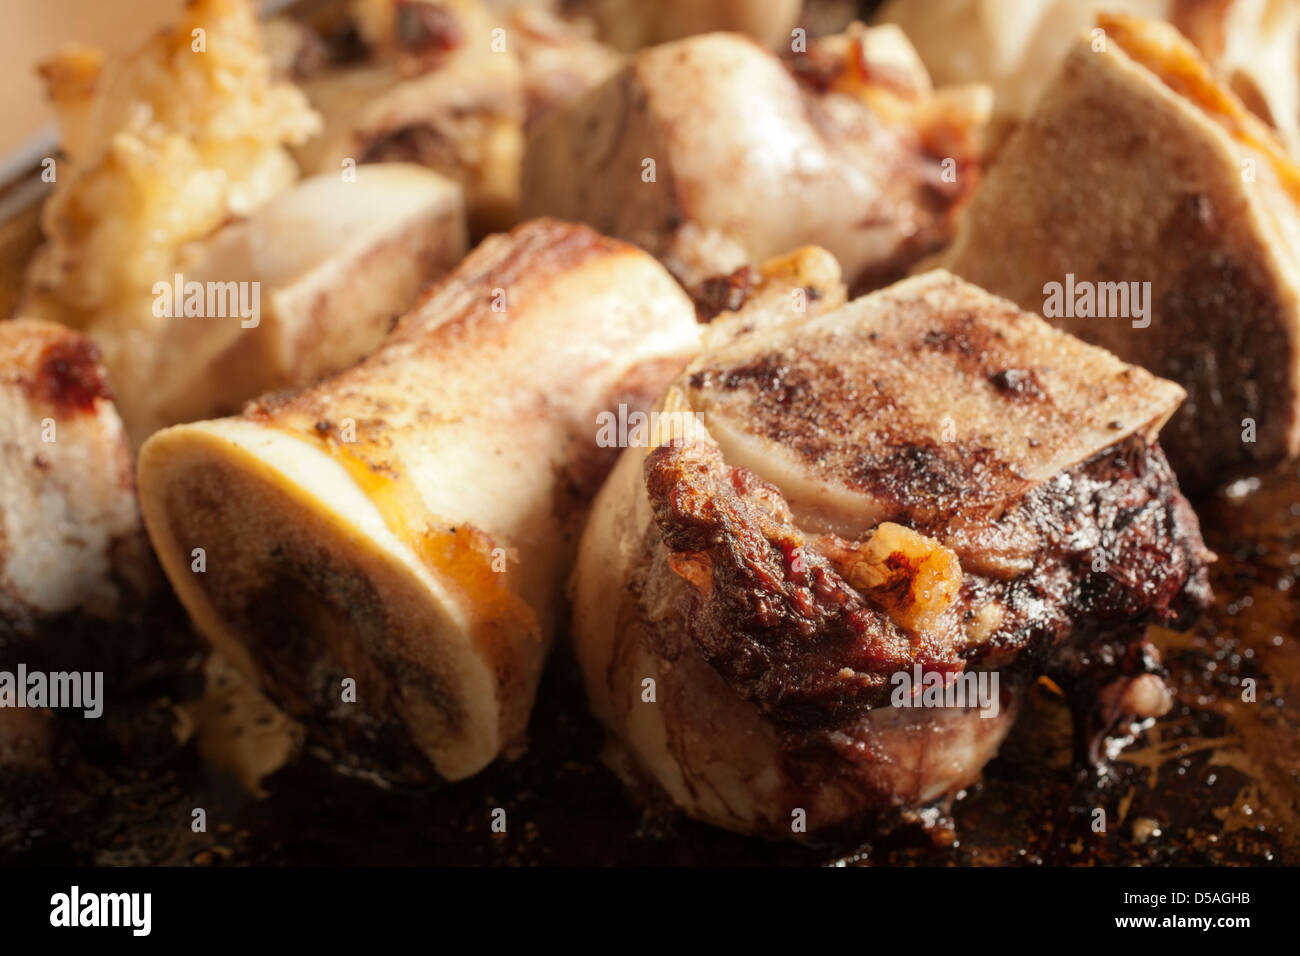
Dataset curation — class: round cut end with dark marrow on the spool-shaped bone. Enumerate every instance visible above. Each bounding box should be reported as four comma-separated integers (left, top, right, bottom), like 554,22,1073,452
139,420,512,780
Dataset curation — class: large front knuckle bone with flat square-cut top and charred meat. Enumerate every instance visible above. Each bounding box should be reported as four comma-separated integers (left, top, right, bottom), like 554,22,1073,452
572,272,1212,836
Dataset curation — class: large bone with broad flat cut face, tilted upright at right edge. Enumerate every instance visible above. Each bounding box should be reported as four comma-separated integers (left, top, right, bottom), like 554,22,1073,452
937,16,1300,493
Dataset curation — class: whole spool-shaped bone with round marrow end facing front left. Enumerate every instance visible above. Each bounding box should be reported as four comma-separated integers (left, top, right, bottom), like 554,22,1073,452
139,221,699,779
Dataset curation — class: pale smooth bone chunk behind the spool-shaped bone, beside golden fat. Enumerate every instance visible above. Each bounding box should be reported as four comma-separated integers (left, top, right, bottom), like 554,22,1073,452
144,163,467,433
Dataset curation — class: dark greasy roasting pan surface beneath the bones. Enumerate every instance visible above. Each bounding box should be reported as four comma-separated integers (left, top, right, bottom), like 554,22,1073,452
0,0,1300,866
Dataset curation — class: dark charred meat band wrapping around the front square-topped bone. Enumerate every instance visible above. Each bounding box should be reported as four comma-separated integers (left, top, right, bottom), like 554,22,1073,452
645,437,1210,731
